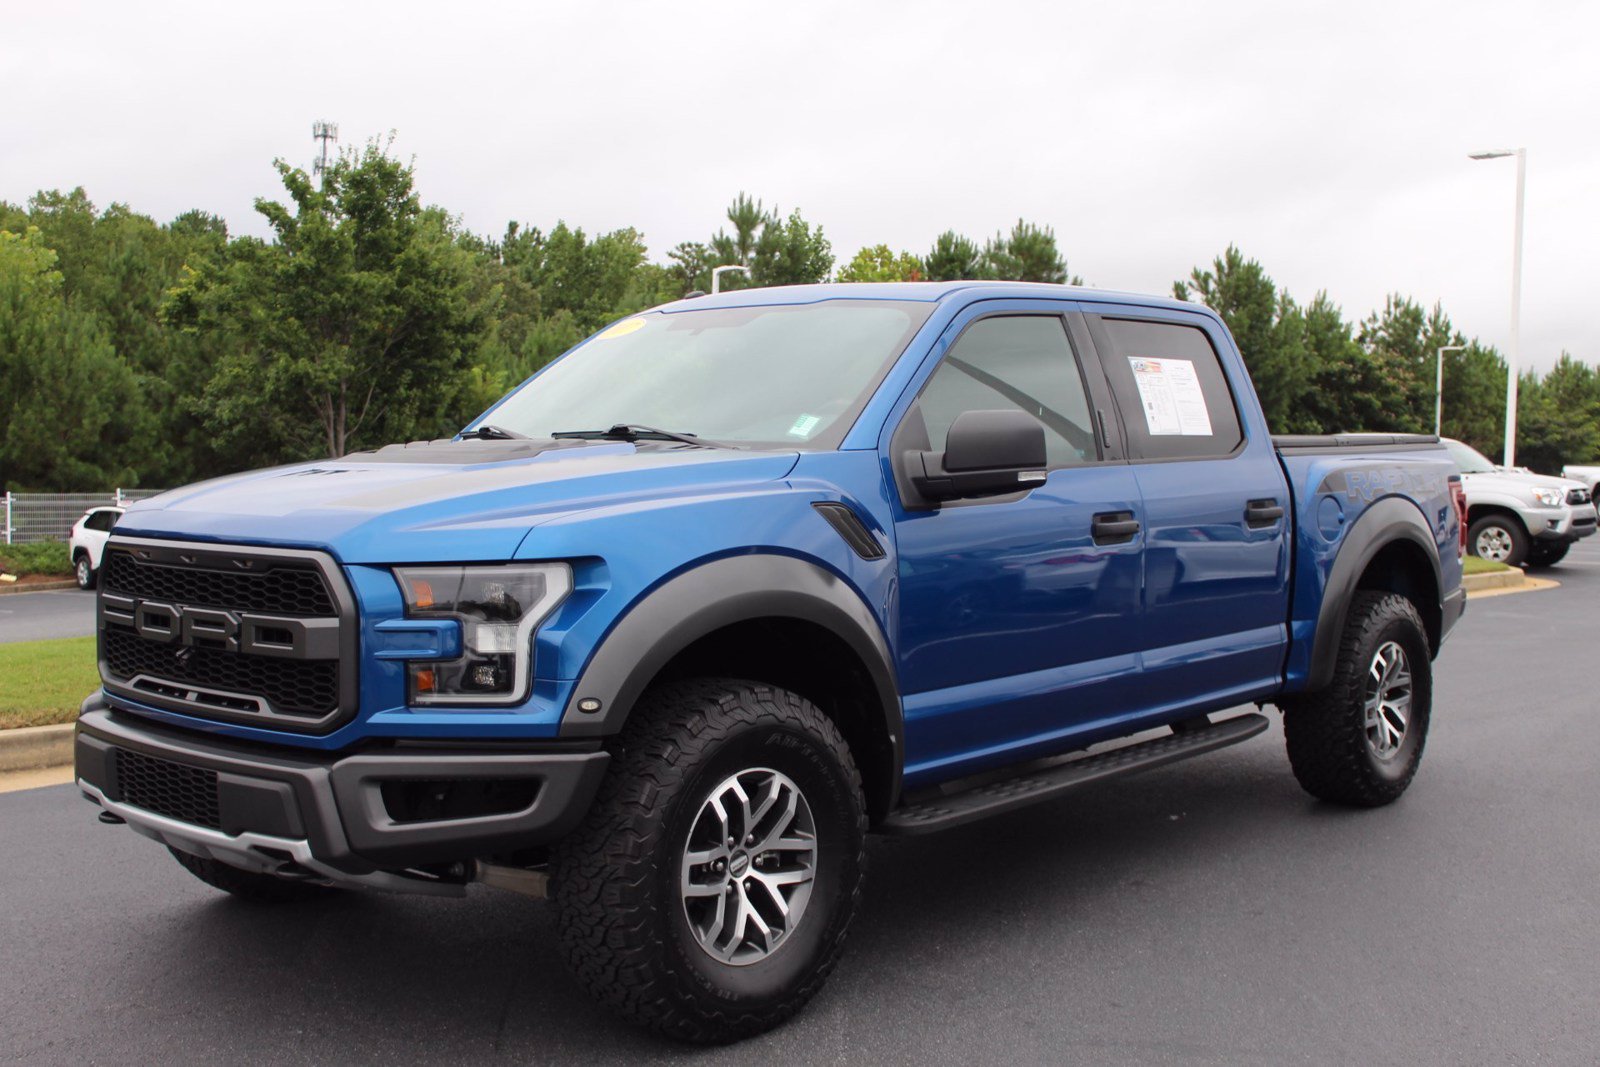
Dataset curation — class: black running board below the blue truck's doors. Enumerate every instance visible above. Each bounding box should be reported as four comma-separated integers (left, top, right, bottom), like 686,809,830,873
877,713,1267,837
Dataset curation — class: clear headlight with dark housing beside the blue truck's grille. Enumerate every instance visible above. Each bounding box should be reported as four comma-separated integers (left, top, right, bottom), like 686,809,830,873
395,563,573,704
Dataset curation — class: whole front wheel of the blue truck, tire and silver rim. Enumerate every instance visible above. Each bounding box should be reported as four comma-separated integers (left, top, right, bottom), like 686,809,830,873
552,680,867,1043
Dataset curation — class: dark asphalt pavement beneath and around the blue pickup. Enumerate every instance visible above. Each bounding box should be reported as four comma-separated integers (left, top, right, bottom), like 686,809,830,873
0,542,1600,1064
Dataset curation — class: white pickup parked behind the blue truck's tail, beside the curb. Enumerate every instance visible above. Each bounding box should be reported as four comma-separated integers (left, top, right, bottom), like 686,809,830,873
1445,437,1595,566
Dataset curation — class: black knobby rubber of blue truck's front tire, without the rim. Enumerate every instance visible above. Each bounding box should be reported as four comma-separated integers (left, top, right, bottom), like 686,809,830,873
550,678,867,1045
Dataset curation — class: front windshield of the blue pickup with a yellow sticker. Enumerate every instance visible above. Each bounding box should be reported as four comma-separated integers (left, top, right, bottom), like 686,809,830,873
485,299,933,450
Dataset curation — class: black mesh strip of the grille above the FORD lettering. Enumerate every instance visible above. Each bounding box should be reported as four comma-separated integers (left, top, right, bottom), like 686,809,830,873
101,550,338,619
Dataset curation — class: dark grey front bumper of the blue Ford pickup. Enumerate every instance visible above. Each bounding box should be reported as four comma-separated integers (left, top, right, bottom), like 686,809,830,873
74,694,610,894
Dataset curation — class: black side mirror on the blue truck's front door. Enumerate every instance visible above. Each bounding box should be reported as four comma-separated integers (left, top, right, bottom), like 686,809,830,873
906,408,1048,501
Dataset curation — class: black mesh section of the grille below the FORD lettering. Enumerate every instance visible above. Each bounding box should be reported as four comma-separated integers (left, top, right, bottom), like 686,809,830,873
101,624,339,718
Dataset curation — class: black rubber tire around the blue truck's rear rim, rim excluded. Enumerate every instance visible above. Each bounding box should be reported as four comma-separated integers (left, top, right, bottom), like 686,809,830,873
1282,592,1434,808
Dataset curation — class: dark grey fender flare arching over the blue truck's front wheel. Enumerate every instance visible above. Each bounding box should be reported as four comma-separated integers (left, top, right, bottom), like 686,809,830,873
560,553,906,803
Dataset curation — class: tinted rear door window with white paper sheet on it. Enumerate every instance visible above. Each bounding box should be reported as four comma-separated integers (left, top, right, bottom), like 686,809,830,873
1096,318,1243,459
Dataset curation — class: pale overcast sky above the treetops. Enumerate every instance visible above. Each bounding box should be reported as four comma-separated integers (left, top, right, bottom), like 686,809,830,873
0,0,1600,366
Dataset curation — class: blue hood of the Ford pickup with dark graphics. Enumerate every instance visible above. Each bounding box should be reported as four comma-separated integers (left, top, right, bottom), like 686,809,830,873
117,440,798,563
